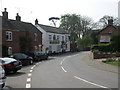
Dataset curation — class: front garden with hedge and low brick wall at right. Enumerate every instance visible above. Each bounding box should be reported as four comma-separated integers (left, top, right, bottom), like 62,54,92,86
91,35,120,66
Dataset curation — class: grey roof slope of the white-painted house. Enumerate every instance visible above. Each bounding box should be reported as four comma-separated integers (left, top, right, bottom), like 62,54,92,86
38,24,68,34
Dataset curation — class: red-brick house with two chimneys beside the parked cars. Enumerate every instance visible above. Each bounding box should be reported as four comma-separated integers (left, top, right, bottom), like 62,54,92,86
1,8,42,56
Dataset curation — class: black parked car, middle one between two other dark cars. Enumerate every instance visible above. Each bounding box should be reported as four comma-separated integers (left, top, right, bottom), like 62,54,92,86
9,53,33,65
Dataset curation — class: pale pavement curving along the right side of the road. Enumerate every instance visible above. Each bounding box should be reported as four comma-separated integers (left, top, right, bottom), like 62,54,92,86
84,52,120,74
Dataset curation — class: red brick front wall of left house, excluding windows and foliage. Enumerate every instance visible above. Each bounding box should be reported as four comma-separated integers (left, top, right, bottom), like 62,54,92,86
2,30,42,56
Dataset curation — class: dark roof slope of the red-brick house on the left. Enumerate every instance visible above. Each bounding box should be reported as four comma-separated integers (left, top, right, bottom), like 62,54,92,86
2,18,40,32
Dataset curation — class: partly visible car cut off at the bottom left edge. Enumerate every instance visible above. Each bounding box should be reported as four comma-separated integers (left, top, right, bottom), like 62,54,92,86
0,62,6,90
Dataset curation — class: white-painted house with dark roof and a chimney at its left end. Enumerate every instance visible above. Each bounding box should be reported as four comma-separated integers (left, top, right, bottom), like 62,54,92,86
35,19,70,53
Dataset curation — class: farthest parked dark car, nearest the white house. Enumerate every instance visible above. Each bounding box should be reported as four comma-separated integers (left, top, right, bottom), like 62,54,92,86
29,51,48,61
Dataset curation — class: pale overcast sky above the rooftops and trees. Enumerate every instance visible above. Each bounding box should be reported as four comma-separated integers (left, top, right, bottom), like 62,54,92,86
0,0,120,25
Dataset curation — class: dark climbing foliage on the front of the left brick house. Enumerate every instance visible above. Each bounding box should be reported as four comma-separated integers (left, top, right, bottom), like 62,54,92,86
20,36,32,53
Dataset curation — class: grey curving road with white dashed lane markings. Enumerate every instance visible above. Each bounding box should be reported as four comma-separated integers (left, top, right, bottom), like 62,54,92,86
3,52,118,90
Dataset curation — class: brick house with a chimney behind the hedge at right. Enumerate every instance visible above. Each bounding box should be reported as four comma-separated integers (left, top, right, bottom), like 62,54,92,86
98,19,120,43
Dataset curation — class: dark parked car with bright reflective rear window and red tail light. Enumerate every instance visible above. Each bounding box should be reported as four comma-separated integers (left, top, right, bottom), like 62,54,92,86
0,58,22,74
